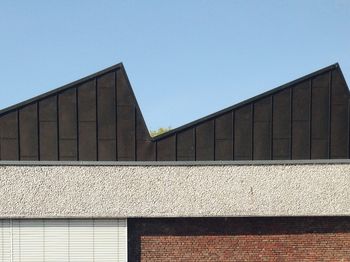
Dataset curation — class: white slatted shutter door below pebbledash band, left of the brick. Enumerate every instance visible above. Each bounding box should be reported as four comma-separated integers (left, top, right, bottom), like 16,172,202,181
0,219,127,262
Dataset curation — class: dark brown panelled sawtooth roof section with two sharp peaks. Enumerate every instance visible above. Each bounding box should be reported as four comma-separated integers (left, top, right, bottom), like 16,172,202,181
0,64,349,161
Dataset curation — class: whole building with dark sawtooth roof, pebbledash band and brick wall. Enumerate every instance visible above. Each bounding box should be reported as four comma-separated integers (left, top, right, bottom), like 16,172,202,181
0,64,350,261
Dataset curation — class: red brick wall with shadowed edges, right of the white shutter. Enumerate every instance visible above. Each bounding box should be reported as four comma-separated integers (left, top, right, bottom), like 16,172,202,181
128,217,350,262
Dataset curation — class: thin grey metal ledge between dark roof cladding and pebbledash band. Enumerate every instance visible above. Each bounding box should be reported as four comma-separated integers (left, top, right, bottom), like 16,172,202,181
0,159,350,166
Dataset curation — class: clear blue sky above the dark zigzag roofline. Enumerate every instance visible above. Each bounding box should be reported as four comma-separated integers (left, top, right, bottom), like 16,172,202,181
0,0,350,129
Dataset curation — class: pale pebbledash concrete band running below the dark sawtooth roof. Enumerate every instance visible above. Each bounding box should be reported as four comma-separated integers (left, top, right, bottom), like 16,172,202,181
0,163,350,218
